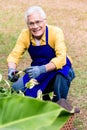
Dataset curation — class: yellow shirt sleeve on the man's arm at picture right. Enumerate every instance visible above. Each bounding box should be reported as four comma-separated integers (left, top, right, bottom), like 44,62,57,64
51,28,66,69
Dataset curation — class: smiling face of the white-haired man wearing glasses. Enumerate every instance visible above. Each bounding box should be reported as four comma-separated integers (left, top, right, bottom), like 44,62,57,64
27,12,46,39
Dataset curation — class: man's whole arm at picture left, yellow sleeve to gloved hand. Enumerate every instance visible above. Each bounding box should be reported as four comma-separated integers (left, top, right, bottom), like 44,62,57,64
7,29,29,82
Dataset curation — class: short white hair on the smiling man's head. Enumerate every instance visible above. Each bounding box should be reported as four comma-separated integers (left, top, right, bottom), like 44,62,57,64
25,6,46,22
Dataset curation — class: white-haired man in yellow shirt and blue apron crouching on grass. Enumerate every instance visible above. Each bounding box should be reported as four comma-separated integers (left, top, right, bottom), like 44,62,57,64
7,6,75,102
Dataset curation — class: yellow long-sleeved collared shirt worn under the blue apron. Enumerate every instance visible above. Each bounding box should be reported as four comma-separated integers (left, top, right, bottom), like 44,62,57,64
7,25,71,69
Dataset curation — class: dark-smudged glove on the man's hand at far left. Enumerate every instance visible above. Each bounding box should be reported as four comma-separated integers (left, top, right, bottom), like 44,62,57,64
8,68,19,82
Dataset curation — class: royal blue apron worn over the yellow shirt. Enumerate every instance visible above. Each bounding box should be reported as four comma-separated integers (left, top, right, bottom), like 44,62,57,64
23,27,71,97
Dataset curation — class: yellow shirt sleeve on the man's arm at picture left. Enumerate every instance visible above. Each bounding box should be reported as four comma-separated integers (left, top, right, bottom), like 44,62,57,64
7,30,29,64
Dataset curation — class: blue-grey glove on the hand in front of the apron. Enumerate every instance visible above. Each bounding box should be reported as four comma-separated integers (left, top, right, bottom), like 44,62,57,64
24,65,46,78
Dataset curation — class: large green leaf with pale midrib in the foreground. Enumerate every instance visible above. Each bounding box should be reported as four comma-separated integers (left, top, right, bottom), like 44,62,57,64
0,95,71,130
